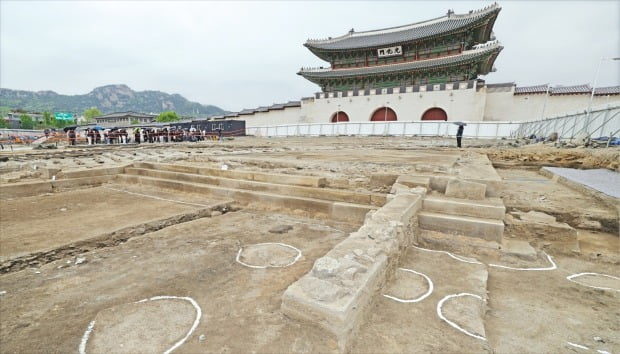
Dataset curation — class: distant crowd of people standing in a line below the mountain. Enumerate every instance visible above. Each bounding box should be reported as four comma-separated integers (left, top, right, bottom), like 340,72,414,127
67,127,222,145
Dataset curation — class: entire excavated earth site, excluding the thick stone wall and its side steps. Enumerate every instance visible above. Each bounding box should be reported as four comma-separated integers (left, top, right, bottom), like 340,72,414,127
0,137,620,353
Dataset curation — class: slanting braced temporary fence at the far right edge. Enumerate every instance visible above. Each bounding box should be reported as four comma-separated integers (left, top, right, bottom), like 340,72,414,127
513,105,620,139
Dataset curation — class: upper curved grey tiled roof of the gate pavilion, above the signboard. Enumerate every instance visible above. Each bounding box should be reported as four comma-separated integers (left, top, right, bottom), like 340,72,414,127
304,3,501,50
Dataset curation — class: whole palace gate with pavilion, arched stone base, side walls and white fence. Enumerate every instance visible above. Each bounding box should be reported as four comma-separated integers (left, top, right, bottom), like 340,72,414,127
224,4,620,138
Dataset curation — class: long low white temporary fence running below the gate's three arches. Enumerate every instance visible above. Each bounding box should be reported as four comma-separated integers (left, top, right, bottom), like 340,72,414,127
246,121,521,139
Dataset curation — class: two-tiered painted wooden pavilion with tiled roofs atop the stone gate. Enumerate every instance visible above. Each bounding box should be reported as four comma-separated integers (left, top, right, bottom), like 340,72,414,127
298,4,503,92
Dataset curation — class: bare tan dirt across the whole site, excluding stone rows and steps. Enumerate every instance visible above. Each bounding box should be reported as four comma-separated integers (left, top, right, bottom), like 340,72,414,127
0,137,620,353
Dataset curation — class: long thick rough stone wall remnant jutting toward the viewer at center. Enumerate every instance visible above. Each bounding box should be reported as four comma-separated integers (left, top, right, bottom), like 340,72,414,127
282,193,422,351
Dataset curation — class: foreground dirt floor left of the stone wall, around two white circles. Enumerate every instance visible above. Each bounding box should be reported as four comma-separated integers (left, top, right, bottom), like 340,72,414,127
0,210,359,353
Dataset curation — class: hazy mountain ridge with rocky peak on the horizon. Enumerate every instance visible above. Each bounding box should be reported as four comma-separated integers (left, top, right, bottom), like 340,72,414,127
0,84,228,117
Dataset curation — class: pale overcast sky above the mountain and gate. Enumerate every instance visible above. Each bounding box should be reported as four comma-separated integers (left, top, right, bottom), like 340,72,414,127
0,0,620,111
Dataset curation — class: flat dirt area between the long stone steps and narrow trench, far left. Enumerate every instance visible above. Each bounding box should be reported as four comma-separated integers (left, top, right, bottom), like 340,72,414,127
0,185,215,262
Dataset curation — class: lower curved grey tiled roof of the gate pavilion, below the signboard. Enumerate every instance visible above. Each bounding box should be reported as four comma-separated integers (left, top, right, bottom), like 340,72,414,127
297,41,503,79
